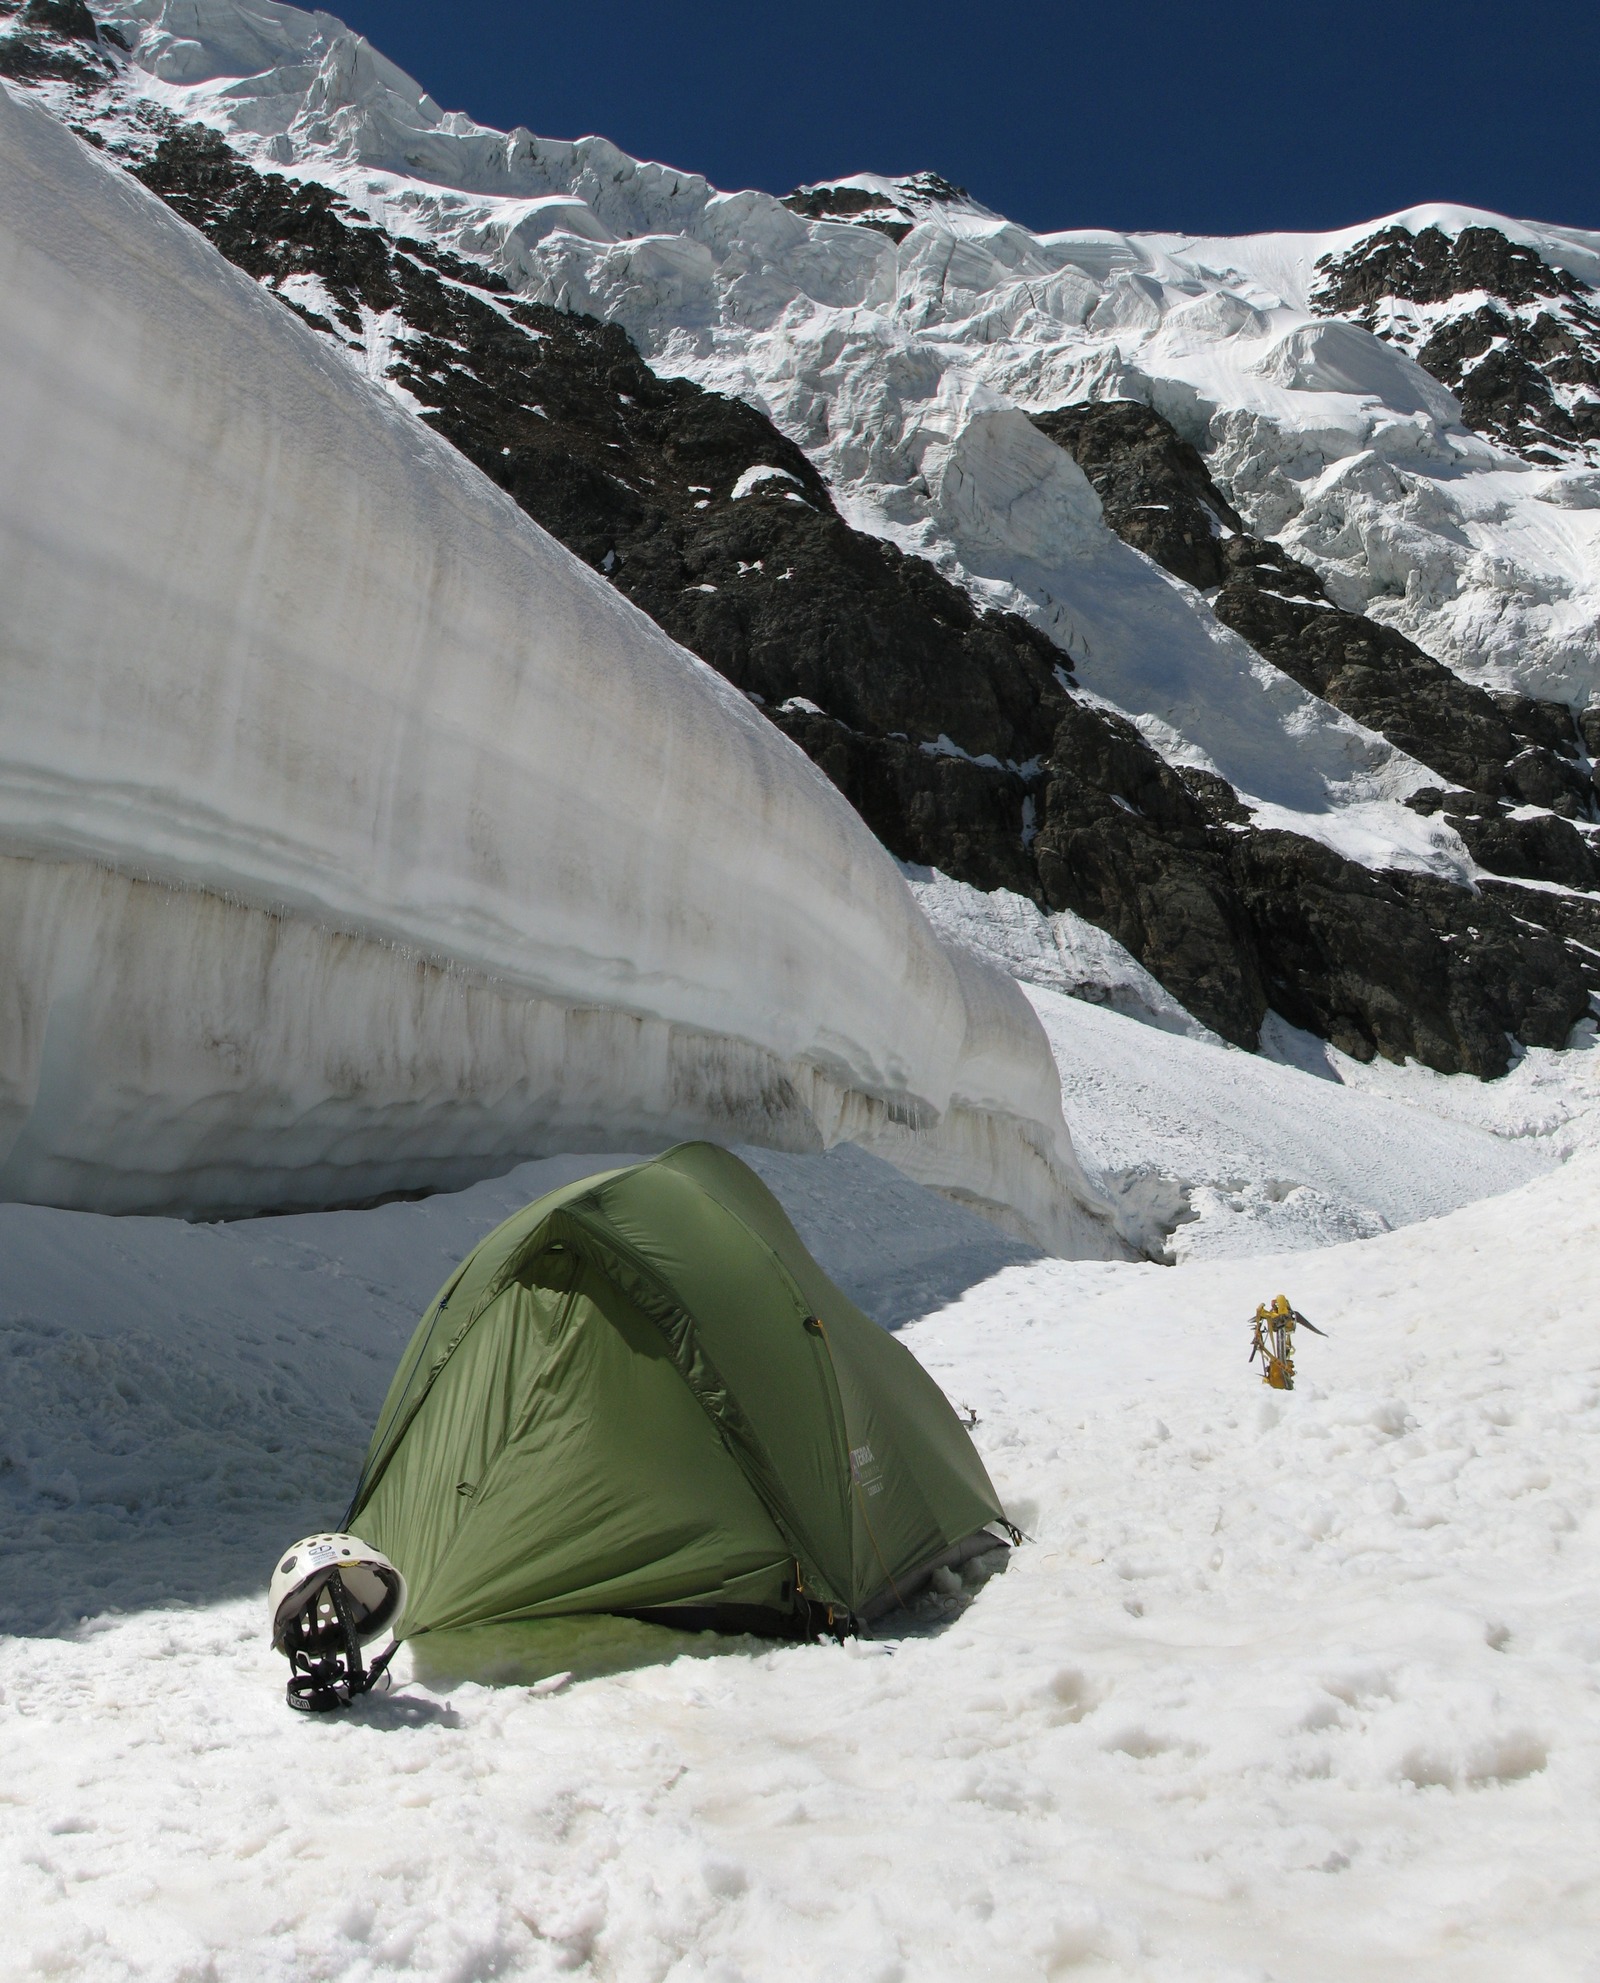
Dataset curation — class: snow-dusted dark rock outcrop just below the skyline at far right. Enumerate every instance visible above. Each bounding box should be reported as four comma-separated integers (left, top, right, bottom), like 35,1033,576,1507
1313,226,1600,462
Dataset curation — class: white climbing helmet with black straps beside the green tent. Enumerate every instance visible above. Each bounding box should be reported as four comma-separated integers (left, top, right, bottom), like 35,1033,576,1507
268,1535,406,1713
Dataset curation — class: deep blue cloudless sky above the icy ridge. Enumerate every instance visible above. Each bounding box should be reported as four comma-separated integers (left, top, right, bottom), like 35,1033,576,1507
329,0,1600,234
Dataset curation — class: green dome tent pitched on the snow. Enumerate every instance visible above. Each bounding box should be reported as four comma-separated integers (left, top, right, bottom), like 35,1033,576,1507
345,1142,1005,1638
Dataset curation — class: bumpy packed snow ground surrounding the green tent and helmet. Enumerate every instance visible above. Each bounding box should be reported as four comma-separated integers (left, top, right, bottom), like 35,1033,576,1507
0,1142,1600,1983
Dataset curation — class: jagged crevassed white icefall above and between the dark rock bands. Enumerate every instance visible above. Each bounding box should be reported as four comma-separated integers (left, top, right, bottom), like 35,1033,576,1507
34,0,1600,873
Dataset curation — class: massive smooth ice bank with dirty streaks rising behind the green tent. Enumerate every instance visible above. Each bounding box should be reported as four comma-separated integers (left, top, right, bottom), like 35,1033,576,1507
0,91,1116,1251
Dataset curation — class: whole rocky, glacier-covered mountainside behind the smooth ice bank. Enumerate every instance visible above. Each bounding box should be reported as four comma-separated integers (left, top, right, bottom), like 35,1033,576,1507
0,0,1600,1197
